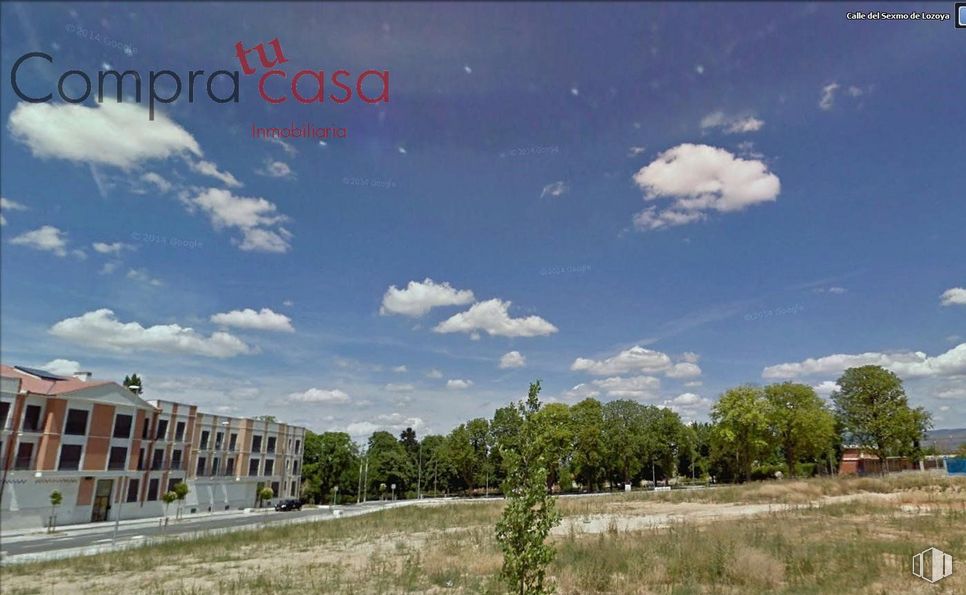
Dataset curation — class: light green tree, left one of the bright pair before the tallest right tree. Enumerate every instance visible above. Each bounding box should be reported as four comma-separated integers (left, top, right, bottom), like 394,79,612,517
711,386,773,481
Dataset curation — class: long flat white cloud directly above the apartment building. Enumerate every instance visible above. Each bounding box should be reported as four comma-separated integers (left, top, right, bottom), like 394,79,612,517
50,308,252,358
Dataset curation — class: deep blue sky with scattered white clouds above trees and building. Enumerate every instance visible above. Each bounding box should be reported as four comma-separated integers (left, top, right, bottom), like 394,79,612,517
0,3,966,437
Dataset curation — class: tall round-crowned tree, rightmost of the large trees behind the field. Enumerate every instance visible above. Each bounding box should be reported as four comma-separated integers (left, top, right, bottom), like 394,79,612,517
832,366,932,463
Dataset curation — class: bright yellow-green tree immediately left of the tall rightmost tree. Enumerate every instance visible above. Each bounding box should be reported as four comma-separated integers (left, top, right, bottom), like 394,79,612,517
765,382,836,476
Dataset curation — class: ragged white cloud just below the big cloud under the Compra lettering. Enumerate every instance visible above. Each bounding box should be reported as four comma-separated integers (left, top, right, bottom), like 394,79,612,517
188,188,292,252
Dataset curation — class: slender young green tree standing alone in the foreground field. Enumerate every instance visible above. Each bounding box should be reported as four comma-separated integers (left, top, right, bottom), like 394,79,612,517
496,380,560,595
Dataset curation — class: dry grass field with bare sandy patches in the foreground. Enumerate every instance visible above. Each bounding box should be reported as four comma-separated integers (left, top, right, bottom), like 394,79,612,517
0,474,966,595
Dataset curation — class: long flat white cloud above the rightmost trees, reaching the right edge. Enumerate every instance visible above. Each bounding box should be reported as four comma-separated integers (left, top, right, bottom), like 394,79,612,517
761,343,966,379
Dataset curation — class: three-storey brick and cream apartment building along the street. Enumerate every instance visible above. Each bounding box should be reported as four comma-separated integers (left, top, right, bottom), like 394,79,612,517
0,365,305,529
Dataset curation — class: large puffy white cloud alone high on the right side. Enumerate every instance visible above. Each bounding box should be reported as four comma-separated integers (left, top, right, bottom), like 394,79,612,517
634,144,781,230
